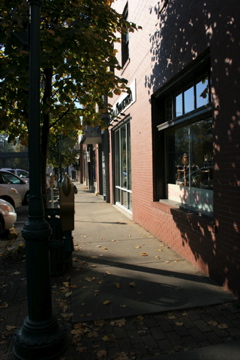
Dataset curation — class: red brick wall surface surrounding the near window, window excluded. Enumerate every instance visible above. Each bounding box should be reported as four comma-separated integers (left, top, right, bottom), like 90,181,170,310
110,0,240,295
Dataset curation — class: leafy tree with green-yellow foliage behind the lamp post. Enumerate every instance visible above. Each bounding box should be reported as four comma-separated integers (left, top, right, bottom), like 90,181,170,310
0,0,137,197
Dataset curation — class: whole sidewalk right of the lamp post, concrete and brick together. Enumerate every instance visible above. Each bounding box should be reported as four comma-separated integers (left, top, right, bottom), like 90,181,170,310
0,185,240,360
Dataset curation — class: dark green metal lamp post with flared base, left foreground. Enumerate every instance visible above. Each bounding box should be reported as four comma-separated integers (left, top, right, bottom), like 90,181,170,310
13,0,68,360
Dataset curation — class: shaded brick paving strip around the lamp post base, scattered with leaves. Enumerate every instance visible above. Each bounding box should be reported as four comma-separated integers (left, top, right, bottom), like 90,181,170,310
0,250,240,360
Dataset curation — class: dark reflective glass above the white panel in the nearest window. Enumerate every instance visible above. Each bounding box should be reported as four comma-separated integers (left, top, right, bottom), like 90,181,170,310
167,120,213,189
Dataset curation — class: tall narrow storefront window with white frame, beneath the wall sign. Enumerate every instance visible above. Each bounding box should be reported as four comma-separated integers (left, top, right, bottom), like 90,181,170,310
114,122,132,210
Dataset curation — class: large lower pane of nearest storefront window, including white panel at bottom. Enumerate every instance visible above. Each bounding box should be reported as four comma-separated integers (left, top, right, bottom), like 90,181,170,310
166,119,213,213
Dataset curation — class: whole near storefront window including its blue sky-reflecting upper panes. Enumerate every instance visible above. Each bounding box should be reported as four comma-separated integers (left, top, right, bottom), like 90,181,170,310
156,64,213,215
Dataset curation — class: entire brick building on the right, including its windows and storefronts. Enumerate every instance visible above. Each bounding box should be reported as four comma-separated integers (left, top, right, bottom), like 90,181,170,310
81,0,240,296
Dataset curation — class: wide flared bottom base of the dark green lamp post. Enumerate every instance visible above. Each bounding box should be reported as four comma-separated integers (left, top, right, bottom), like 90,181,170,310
13,317,69,360
